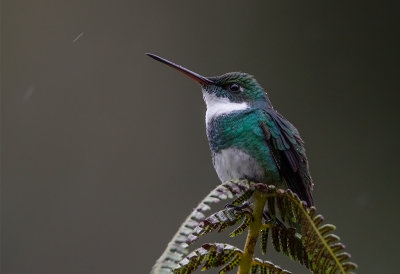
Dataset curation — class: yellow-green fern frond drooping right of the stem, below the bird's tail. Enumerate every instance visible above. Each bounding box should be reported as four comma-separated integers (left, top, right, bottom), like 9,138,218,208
262,186,357,273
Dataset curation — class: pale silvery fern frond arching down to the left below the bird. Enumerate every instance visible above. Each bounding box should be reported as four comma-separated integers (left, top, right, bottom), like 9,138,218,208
151,180,254,274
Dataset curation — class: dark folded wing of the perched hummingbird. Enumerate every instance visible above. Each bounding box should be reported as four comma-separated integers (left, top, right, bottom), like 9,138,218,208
260,109,314,206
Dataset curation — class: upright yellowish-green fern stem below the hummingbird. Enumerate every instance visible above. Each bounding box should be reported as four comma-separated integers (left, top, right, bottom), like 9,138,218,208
237,189,267,274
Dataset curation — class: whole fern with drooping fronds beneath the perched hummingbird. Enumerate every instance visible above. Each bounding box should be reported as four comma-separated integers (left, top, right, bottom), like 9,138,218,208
152,180,357,273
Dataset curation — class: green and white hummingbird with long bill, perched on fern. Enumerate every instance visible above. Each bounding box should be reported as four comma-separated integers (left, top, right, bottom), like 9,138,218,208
146,53,314,206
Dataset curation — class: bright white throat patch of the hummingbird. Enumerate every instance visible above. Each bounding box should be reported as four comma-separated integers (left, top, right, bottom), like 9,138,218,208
203,91,249,124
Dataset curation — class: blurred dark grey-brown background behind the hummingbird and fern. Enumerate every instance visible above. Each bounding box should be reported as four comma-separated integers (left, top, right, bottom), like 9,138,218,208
1,0,400,274
